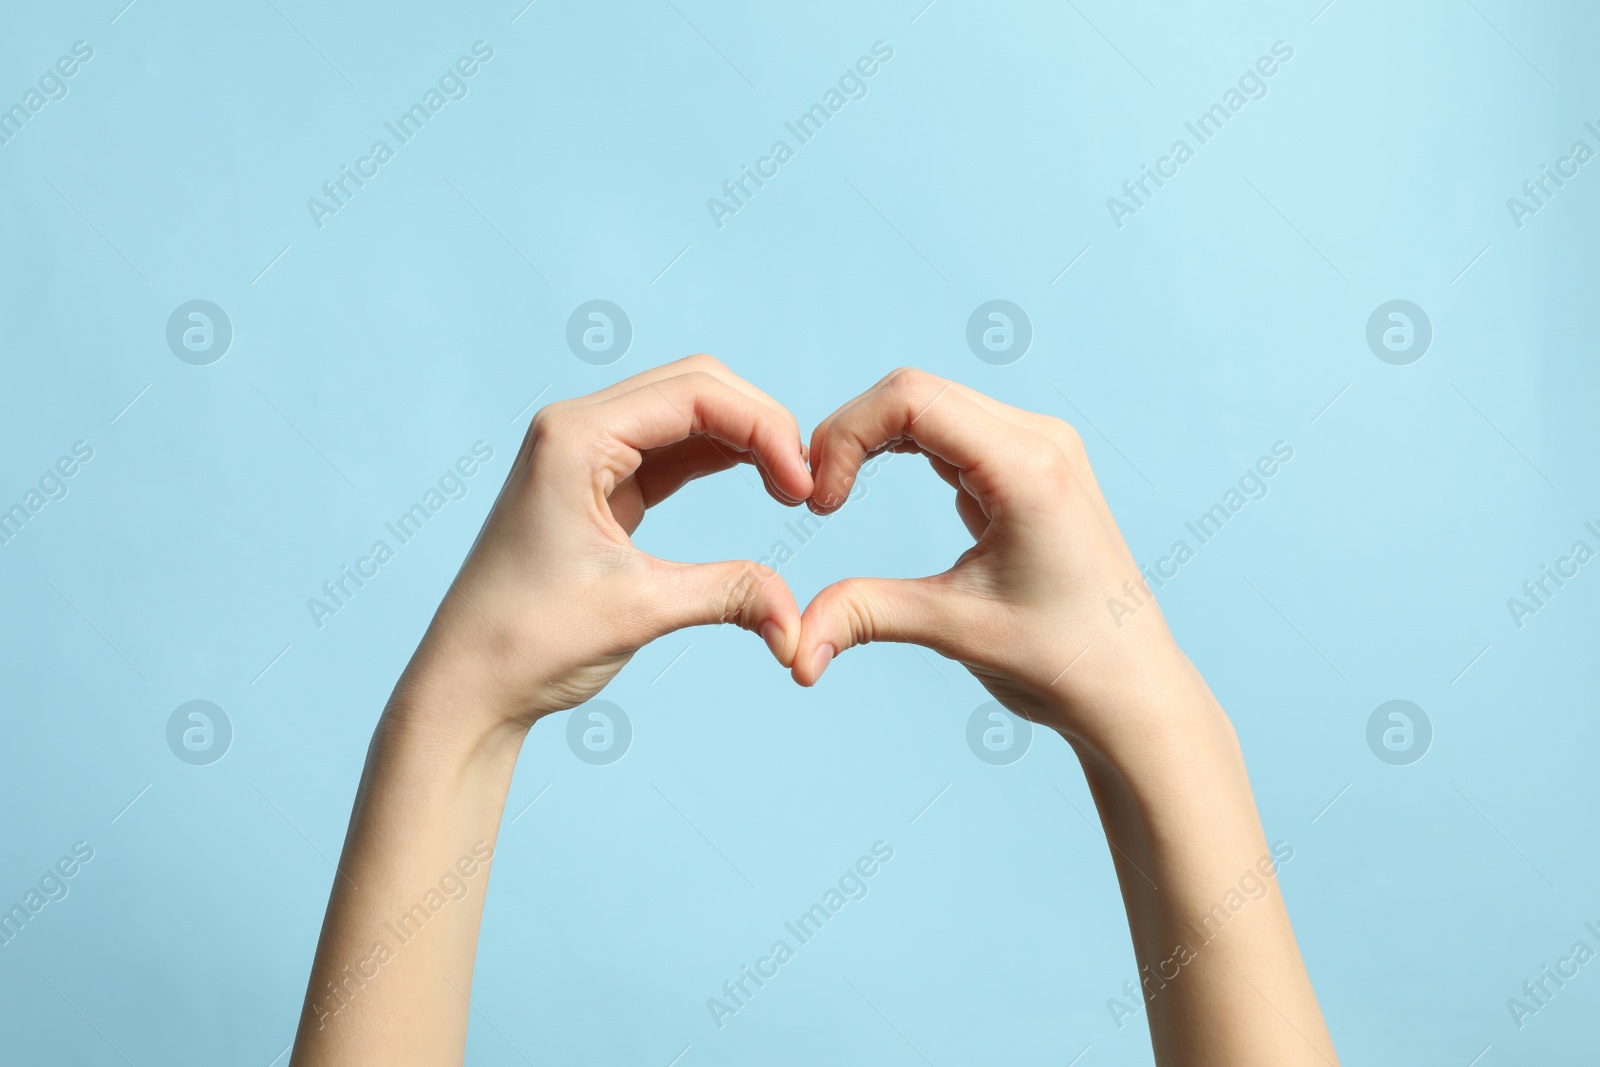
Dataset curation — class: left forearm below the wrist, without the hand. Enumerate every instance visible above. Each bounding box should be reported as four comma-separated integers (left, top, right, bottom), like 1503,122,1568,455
291,672,525,1067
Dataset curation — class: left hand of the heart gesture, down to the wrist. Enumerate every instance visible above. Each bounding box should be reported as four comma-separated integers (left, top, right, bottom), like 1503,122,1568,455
397,355,811,729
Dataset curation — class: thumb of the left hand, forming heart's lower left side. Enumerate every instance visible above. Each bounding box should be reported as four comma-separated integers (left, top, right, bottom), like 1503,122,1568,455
646,560,800,667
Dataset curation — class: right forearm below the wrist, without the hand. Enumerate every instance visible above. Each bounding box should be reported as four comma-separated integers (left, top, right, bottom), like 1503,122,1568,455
1074,653,1338,1067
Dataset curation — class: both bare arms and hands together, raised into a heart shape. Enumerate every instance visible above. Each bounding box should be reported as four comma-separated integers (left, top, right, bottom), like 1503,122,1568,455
293,355,1338,1067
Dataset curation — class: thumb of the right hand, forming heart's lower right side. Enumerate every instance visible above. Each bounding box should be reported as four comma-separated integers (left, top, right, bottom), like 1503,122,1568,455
792,577,958,686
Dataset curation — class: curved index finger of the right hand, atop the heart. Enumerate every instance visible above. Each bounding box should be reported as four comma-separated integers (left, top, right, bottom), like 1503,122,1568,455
811,370,1038,512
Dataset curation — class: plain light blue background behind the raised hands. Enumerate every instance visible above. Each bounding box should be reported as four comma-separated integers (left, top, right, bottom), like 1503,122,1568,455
0,0,1600,1067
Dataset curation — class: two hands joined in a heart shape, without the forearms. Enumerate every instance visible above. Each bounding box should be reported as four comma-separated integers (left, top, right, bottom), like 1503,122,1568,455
489,355,1139,726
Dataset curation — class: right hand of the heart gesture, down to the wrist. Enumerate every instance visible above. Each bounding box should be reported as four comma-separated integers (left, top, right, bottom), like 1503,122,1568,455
794,370,1192,751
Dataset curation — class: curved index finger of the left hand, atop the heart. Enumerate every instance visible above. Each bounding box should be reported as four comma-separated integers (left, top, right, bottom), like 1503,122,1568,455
588,371,811,502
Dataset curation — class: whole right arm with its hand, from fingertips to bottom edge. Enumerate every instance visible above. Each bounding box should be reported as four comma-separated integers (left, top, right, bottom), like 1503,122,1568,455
794,370,1338,1067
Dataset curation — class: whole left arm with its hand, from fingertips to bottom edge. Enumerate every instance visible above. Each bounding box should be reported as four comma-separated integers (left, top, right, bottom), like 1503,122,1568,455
293,357,811,1067
